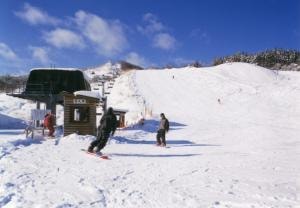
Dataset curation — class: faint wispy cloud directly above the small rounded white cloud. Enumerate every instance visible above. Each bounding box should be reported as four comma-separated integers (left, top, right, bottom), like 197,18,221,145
137,13,166,35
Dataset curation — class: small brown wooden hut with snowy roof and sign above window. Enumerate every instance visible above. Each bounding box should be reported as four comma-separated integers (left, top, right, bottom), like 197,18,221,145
62,91,100,136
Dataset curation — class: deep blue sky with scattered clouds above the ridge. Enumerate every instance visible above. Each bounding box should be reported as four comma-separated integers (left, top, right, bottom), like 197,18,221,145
0,0,300,74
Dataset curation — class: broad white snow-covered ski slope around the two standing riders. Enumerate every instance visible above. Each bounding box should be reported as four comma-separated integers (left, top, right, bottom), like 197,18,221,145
0,63,300,208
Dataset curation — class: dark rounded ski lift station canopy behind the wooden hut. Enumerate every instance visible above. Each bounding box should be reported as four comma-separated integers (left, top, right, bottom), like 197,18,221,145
10,68,91,114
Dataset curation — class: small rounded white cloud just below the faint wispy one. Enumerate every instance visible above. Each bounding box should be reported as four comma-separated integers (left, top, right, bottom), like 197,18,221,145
153,33,176,50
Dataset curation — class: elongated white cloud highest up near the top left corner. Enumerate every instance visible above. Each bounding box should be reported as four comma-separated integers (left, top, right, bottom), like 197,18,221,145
15,3,60,25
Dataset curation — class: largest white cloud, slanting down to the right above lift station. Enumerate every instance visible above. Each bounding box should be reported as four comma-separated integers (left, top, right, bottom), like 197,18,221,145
75,11,128,56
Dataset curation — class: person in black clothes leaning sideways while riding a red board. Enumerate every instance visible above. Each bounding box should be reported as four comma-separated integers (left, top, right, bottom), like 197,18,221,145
88,107,117,152
